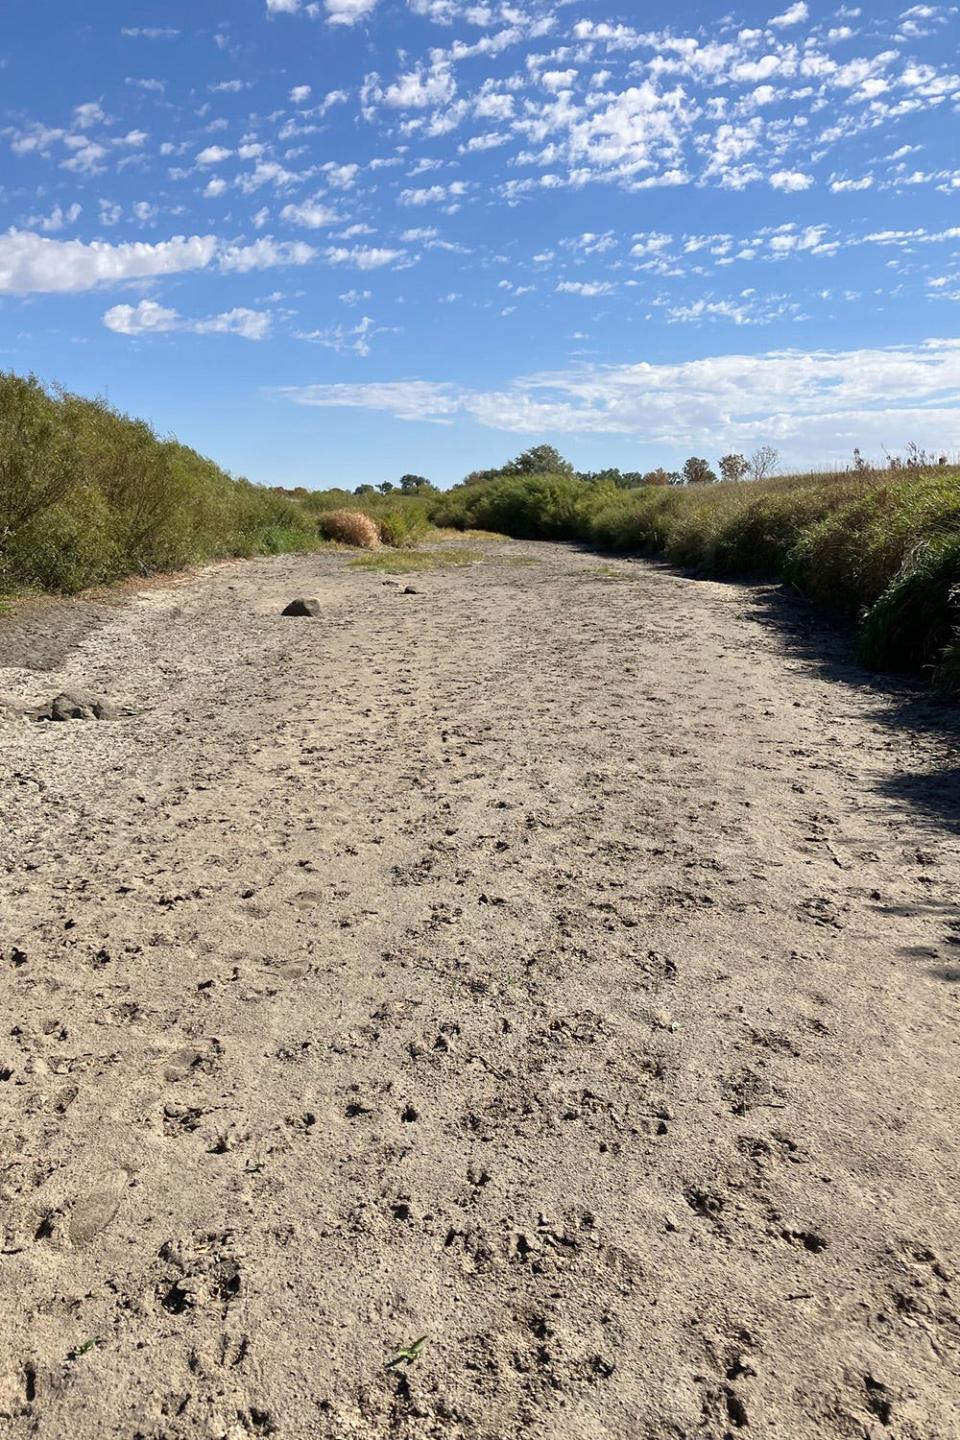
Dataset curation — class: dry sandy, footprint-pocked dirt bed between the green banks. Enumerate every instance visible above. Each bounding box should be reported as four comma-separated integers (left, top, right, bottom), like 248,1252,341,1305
0,544,960,1440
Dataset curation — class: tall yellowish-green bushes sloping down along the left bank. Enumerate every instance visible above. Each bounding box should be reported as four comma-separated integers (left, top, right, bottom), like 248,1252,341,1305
0,373,318,592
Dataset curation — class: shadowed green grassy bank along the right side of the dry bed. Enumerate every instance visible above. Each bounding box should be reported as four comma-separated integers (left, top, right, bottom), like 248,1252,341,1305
432,468,960,693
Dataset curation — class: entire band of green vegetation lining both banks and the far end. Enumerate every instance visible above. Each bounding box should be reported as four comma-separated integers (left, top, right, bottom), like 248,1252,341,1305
7,373,960,694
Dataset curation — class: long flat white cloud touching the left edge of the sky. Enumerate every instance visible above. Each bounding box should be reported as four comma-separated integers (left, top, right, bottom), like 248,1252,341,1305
0,230,219,295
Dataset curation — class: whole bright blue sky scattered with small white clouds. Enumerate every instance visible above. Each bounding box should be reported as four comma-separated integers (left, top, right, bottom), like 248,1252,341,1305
0,0,960,487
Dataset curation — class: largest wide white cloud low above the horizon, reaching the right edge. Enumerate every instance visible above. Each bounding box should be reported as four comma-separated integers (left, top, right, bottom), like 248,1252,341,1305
278,340,960,459
